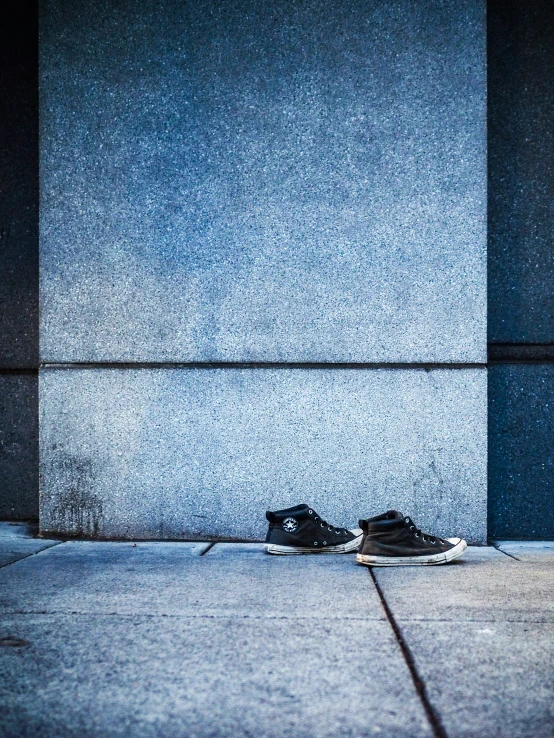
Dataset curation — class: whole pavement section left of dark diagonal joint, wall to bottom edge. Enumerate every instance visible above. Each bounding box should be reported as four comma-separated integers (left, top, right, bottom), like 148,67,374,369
0,541,433,738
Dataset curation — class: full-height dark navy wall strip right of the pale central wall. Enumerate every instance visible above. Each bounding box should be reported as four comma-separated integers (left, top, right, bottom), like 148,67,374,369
488,0,554,538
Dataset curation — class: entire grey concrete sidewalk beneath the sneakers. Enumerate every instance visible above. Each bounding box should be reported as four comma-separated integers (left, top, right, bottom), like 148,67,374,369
0,524,554,738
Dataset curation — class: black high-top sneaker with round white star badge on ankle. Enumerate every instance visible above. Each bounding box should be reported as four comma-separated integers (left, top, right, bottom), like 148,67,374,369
265,505,362,554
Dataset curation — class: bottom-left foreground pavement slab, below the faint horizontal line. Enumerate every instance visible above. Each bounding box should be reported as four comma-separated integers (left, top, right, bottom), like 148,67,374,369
0,615,433,738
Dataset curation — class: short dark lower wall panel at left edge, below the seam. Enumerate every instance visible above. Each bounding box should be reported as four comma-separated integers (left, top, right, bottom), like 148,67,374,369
0,371,39,519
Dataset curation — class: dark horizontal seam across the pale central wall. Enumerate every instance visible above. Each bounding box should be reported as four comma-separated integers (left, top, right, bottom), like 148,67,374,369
40,361,486,371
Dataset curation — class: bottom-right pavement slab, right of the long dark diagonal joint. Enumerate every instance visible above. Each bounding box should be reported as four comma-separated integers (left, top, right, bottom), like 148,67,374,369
396,620,554,738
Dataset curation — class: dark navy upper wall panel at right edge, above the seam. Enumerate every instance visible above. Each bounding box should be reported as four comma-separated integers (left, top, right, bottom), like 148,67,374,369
487,0,554,343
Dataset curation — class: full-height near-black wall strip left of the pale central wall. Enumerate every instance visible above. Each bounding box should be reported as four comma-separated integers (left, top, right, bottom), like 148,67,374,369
0,2,39,519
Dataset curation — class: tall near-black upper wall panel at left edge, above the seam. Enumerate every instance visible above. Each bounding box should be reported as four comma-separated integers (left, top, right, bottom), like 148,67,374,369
0,0,39,368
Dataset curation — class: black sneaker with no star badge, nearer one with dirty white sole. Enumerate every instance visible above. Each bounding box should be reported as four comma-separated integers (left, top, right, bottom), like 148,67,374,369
356,510,467,566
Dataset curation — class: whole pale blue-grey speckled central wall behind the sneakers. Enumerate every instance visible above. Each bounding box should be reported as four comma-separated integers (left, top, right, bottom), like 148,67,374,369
40,0,486,541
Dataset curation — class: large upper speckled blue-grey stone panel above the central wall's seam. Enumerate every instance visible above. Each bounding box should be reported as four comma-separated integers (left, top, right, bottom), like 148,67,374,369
41,0,486,362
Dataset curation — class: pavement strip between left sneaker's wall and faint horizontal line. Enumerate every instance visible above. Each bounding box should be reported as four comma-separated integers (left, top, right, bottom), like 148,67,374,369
0,541,385,620
